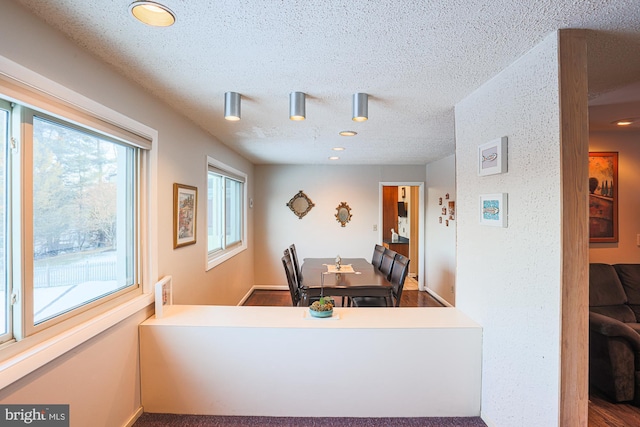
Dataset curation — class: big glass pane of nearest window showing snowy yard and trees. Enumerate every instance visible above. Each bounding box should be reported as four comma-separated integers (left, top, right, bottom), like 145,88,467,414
32,116,136,324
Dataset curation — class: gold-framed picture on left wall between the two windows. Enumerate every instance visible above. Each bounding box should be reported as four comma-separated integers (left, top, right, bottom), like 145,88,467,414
173,184,198,249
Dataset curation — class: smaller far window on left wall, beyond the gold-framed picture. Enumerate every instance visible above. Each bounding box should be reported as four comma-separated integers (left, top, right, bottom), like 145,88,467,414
207,158,247,268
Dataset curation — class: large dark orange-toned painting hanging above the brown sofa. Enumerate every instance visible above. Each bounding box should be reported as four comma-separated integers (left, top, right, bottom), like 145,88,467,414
589,152,618,243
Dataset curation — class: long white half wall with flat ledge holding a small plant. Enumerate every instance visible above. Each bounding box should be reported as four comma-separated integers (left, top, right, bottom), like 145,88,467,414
140,305,482,417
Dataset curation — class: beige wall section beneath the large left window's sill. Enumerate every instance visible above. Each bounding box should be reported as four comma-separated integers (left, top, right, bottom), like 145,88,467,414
0,309,152,427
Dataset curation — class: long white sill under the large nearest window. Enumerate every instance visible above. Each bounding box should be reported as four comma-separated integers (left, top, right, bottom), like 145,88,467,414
0,294,154,390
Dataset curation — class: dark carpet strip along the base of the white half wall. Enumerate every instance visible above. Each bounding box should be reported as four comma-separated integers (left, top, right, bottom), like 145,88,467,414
133,413,487,427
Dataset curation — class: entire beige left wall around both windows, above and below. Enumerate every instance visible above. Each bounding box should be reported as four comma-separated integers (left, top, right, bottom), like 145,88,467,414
0,1,253,427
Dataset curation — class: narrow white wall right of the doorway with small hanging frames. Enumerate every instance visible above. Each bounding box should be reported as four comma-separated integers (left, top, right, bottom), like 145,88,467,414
425,156,458,305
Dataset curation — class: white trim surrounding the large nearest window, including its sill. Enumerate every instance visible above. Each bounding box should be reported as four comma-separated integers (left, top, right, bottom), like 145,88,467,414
0,56,158,389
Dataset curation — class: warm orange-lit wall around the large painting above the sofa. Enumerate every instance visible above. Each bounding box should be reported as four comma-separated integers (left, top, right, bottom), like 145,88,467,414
589,132,640,264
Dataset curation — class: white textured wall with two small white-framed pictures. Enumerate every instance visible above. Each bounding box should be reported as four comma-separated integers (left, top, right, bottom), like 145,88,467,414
456,34,561,427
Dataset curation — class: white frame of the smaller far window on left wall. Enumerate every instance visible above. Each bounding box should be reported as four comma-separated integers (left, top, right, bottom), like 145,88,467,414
205,156,248,271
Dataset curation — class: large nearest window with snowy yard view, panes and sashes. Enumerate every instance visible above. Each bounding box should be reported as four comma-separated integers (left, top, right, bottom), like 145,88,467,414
0,96,142,341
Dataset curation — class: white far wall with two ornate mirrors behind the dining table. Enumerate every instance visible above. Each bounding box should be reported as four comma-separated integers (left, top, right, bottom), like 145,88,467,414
253,165,425,285
